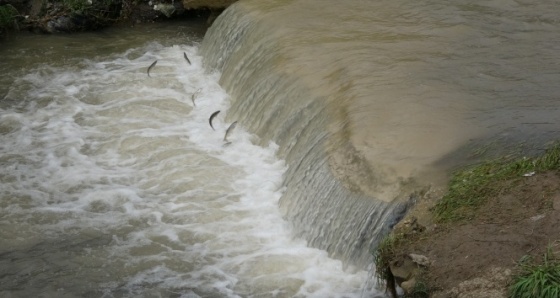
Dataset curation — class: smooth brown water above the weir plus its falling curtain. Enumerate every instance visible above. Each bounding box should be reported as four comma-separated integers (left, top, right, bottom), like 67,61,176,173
201,0,559,265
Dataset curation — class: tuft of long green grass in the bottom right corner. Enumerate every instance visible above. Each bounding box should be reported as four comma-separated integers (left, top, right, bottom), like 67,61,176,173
508,248,560,298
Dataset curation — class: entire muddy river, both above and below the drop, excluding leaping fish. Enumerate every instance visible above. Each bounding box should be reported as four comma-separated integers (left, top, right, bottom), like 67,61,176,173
0,0,560,297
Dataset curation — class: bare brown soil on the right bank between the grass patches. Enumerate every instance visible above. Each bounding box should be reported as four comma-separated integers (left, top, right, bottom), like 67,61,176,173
394,172,560,298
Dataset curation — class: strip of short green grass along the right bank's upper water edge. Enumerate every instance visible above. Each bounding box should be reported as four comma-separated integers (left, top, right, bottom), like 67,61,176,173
434,143,560,222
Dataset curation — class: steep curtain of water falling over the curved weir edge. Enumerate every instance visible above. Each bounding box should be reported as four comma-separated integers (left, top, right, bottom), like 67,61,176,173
201,3,409,267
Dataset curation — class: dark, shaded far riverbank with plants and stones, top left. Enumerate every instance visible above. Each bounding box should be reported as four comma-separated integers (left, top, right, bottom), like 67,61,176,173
0,0,236,38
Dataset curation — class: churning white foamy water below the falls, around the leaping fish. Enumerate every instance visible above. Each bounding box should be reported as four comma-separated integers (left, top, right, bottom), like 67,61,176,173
0,43,380,297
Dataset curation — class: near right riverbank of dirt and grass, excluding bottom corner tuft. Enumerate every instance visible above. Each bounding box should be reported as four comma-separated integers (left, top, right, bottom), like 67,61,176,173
377,145,560,298
